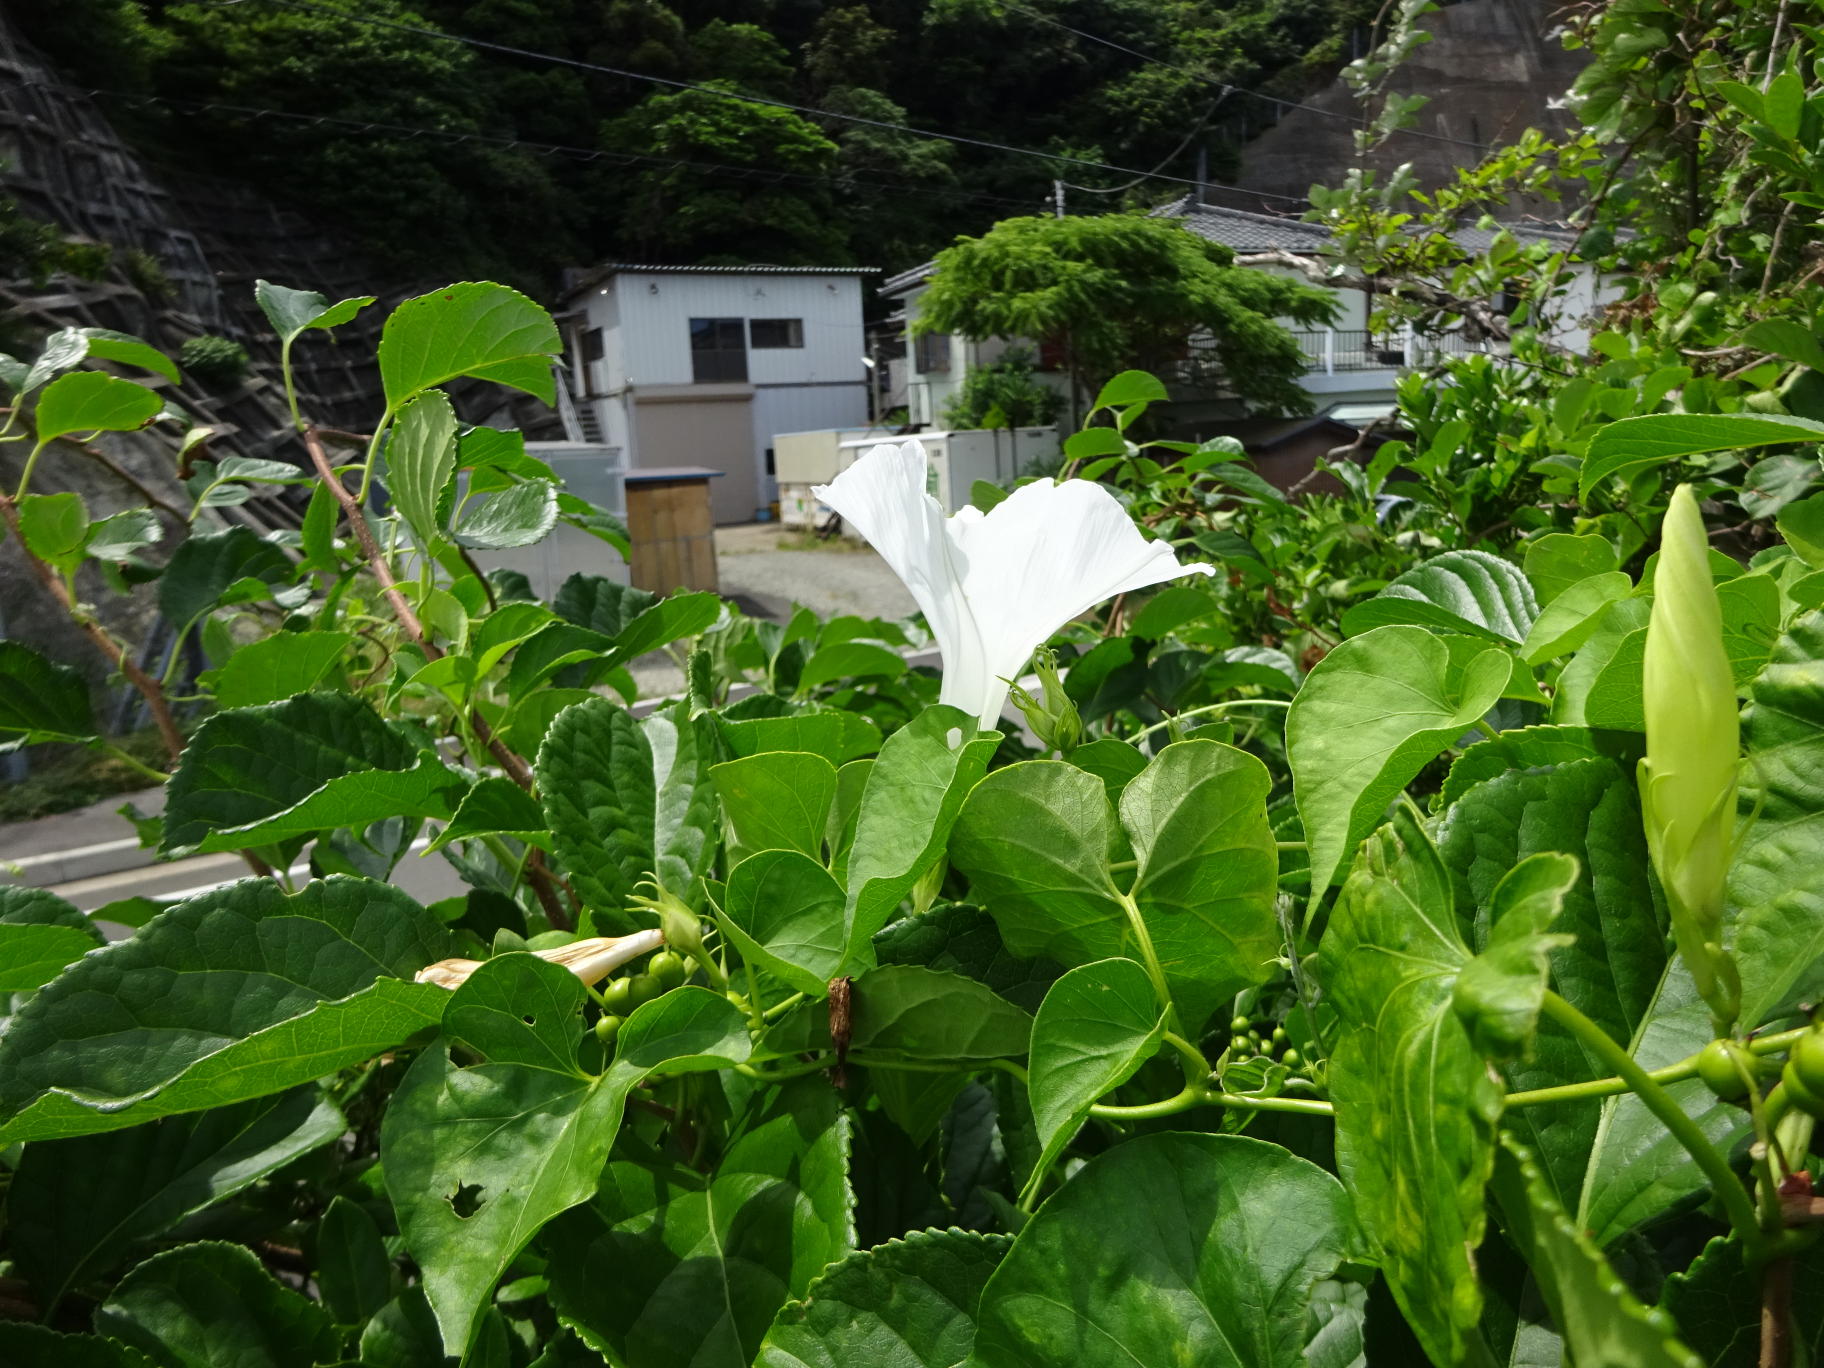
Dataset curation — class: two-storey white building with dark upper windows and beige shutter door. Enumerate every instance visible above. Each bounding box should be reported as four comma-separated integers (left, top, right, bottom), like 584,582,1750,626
558,263,874,523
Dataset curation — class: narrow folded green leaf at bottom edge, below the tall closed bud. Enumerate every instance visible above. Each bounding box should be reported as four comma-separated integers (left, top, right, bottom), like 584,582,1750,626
1492,1136,1716,1368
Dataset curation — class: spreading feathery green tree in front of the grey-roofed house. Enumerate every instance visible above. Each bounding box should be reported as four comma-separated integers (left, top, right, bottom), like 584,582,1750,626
914,213,1335,412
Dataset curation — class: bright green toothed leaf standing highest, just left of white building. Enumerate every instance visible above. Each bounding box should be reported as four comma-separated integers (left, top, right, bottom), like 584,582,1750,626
379,281,564,409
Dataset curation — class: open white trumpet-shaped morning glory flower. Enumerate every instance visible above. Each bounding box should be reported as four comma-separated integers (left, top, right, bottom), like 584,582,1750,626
812,441,1215,728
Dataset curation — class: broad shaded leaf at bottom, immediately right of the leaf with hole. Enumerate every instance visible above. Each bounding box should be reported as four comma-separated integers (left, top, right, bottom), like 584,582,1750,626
544,1078,855,1368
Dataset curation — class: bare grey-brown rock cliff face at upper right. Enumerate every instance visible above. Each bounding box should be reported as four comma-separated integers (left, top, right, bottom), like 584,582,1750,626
1237,0,1585,206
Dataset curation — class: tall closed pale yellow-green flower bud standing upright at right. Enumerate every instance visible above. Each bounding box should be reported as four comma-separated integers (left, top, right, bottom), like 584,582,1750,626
1640,485,1742,1034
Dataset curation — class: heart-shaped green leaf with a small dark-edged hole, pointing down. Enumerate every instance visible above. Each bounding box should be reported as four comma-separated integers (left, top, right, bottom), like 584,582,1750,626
381,954,748,1355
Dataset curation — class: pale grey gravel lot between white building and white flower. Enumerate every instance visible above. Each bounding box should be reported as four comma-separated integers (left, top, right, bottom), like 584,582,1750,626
631,522,917,699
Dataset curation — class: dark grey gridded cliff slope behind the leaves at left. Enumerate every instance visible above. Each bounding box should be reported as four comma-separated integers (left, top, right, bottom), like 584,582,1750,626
0,11,395,711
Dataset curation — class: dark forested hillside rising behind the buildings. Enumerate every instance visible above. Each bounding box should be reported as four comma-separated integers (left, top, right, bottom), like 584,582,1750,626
15,0,1377,286
